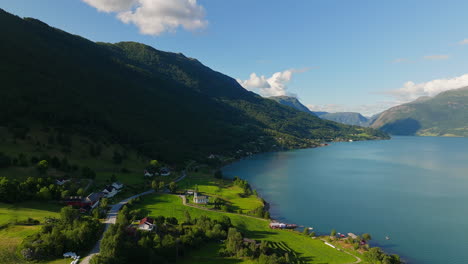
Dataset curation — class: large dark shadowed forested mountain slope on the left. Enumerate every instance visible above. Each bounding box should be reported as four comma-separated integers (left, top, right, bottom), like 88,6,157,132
0,10,386,162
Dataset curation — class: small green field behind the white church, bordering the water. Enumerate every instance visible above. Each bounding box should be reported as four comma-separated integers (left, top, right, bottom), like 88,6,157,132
178,172,263,213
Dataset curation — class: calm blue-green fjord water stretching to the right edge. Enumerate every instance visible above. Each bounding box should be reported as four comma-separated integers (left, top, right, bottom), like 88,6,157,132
223,137,468,264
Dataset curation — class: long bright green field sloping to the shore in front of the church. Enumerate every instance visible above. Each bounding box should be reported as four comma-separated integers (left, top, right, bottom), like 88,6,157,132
136,194,355,264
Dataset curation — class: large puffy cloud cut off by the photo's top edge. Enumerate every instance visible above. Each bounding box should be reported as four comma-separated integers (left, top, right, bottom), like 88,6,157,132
83,0,208,35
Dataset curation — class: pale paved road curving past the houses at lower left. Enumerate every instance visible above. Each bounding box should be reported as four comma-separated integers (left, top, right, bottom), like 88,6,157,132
80,171,187,264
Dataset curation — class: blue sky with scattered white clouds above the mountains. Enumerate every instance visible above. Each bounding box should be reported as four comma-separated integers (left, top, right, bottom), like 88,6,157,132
0,0,468,114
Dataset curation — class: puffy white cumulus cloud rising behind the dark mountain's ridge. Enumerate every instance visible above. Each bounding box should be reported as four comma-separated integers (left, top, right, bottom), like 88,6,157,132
237,68,309,96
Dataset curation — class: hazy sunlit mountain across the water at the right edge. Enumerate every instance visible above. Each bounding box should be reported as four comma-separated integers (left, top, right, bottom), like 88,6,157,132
372,87,468,137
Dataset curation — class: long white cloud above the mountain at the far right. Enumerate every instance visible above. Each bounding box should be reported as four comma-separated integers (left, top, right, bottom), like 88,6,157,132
386,74,468,103
